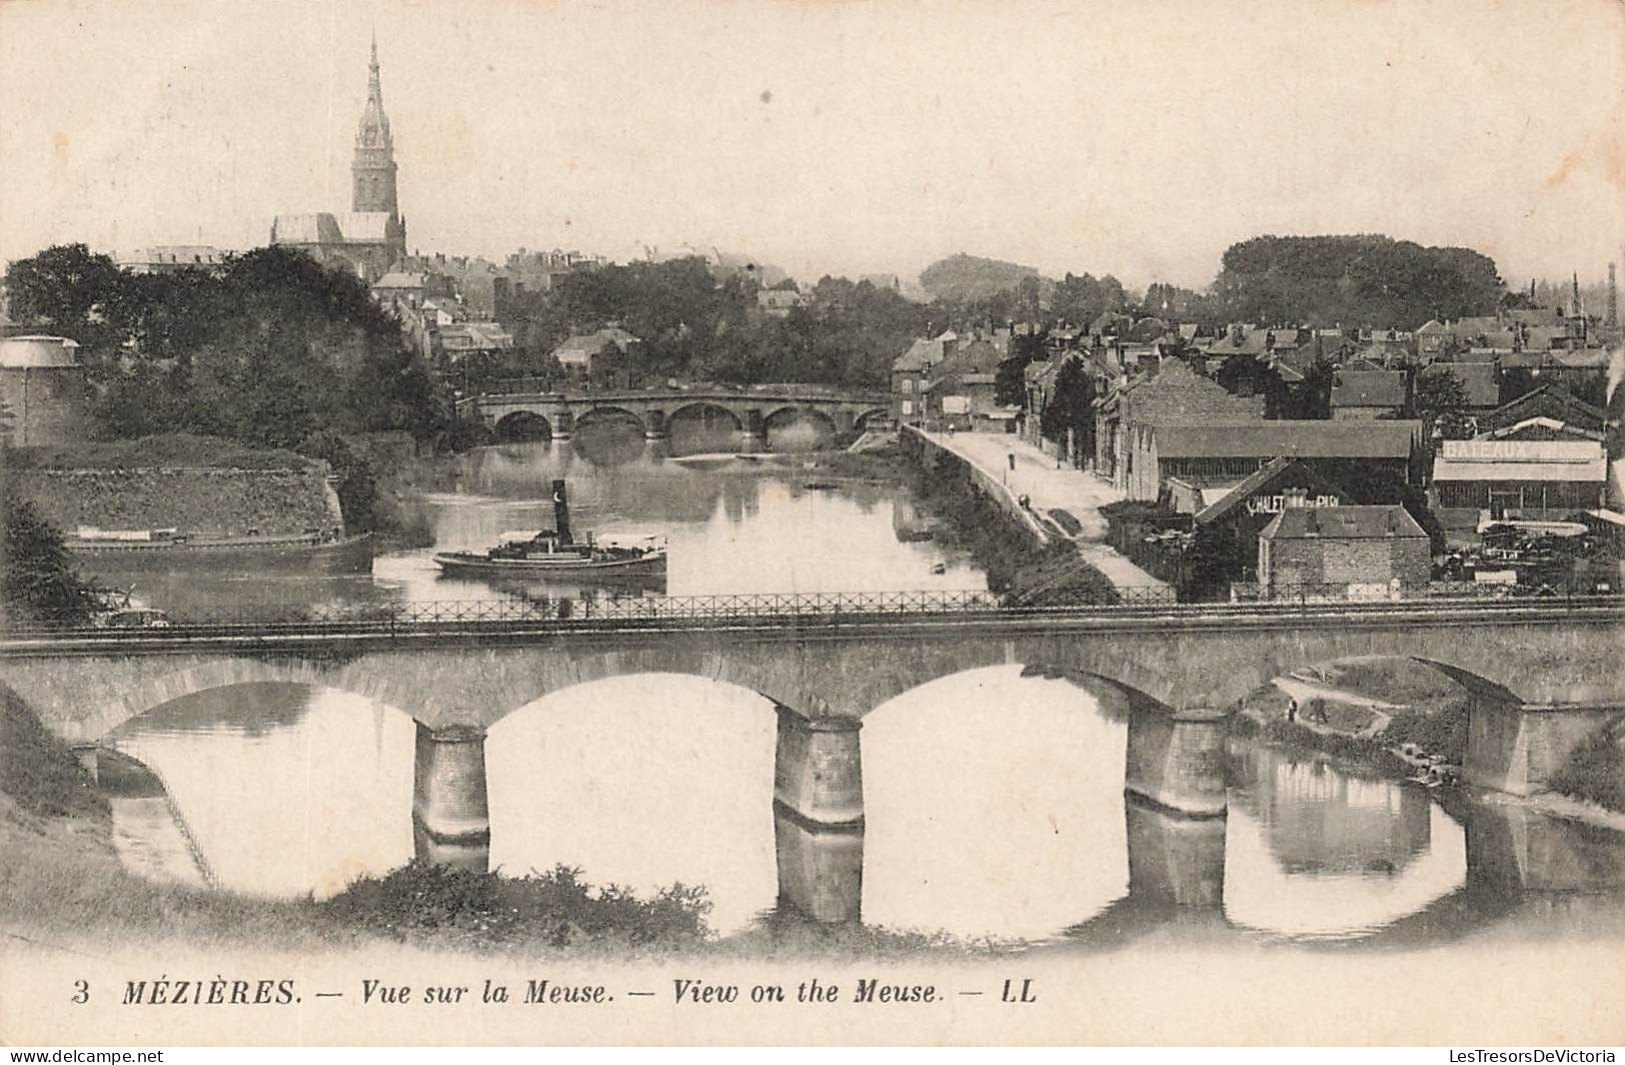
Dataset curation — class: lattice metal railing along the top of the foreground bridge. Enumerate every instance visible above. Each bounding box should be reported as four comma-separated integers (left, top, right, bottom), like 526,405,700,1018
0,584,1625,639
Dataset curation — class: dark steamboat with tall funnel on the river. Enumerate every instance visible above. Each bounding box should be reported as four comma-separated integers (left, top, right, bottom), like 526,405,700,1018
434,480,666,582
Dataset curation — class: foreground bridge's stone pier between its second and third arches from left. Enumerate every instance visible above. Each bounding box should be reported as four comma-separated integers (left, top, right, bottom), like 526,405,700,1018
774,706,863,828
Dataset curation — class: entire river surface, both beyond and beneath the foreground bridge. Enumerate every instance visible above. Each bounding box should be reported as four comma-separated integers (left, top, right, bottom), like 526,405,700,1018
85,437,1625,946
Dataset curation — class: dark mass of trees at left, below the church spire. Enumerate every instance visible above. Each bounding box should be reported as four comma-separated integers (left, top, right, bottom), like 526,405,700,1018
7,244,453,530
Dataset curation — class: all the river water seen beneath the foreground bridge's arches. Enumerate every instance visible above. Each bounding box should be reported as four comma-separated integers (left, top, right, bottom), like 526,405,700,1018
104,665,1625,950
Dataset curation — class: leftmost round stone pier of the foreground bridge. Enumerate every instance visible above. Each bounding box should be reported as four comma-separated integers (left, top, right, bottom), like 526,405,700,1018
411,722,491,868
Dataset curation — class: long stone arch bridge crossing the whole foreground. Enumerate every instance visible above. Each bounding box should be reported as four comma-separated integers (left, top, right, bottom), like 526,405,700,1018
0,603,1625,813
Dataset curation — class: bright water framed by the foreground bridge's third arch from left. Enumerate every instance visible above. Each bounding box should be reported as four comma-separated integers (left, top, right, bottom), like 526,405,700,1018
863,665,1128,940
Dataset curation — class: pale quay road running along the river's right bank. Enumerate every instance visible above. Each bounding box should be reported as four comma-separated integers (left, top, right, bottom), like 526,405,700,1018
913,429,1167,590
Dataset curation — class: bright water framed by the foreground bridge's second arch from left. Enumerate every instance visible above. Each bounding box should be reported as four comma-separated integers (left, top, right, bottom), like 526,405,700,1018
486,675,778,933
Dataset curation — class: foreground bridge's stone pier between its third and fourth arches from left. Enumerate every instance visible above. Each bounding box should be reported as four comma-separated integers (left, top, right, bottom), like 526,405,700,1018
1123,709,1230,818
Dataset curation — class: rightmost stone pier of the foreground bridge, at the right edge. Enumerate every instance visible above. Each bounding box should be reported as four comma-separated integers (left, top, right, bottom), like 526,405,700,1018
1463,698,1625,795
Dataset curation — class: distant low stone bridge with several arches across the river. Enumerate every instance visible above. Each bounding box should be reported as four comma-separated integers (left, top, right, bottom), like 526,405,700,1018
463,385,891,442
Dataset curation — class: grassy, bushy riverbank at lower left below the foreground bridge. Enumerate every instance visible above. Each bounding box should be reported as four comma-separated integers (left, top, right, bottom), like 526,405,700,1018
0,688,998,961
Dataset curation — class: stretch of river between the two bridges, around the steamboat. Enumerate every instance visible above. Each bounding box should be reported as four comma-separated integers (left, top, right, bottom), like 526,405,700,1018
89,439,986,615
